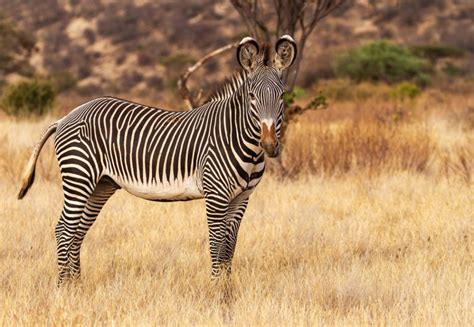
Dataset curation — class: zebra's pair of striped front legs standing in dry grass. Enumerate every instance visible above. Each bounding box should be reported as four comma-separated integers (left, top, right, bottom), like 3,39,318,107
206,194,248,279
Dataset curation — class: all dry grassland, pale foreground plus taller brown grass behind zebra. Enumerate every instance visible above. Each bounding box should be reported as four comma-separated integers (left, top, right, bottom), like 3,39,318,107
0,86,474,326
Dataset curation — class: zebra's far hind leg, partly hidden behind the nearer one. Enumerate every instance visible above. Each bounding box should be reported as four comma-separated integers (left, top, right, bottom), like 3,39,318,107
69,178,117,279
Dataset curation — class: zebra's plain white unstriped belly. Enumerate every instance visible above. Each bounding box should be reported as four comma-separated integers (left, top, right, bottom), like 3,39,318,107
114,176,204,201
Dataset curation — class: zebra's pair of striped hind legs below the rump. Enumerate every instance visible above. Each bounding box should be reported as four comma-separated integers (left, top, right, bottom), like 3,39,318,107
55,178,117,286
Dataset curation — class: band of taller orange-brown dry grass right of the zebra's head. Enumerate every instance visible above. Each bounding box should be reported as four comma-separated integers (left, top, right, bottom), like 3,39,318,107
270,85,474,184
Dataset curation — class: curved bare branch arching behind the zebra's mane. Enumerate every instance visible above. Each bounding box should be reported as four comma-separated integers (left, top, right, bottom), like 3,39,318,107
178,43,238,109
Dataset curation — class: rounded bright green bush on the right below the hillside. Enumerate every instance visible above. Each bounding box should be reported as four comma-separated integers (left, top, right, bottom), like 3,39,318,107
334,41,428,84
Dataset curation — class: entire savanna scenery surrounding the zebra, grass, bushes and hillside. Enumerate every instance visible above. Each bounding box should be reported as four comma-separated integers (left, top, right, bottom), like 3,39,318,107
0,0,474,326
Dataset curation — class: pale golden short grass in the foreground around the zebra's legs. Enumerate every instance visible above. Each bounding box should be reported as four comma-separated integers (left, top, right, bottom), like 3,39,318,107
0,172,474,326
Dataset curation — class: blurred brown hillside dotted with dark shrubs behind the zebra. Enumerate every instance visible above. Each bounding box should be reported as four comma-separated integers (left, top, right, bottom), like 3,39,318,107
0,0,474,103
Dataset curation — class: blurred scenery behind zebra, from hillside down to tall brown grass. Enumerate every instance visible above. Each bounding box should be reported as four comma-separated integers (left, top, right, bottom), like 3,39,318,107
0,0,474,182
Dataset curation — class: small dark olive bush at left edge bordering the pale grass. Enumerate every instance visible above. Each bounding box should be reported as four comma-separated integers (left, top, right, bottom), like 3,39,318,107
2,80,56,117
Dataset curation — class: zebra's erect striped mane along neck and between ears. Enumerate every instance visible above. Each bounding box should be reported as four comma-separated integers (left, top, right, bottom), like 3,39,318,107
204,43,271,103
